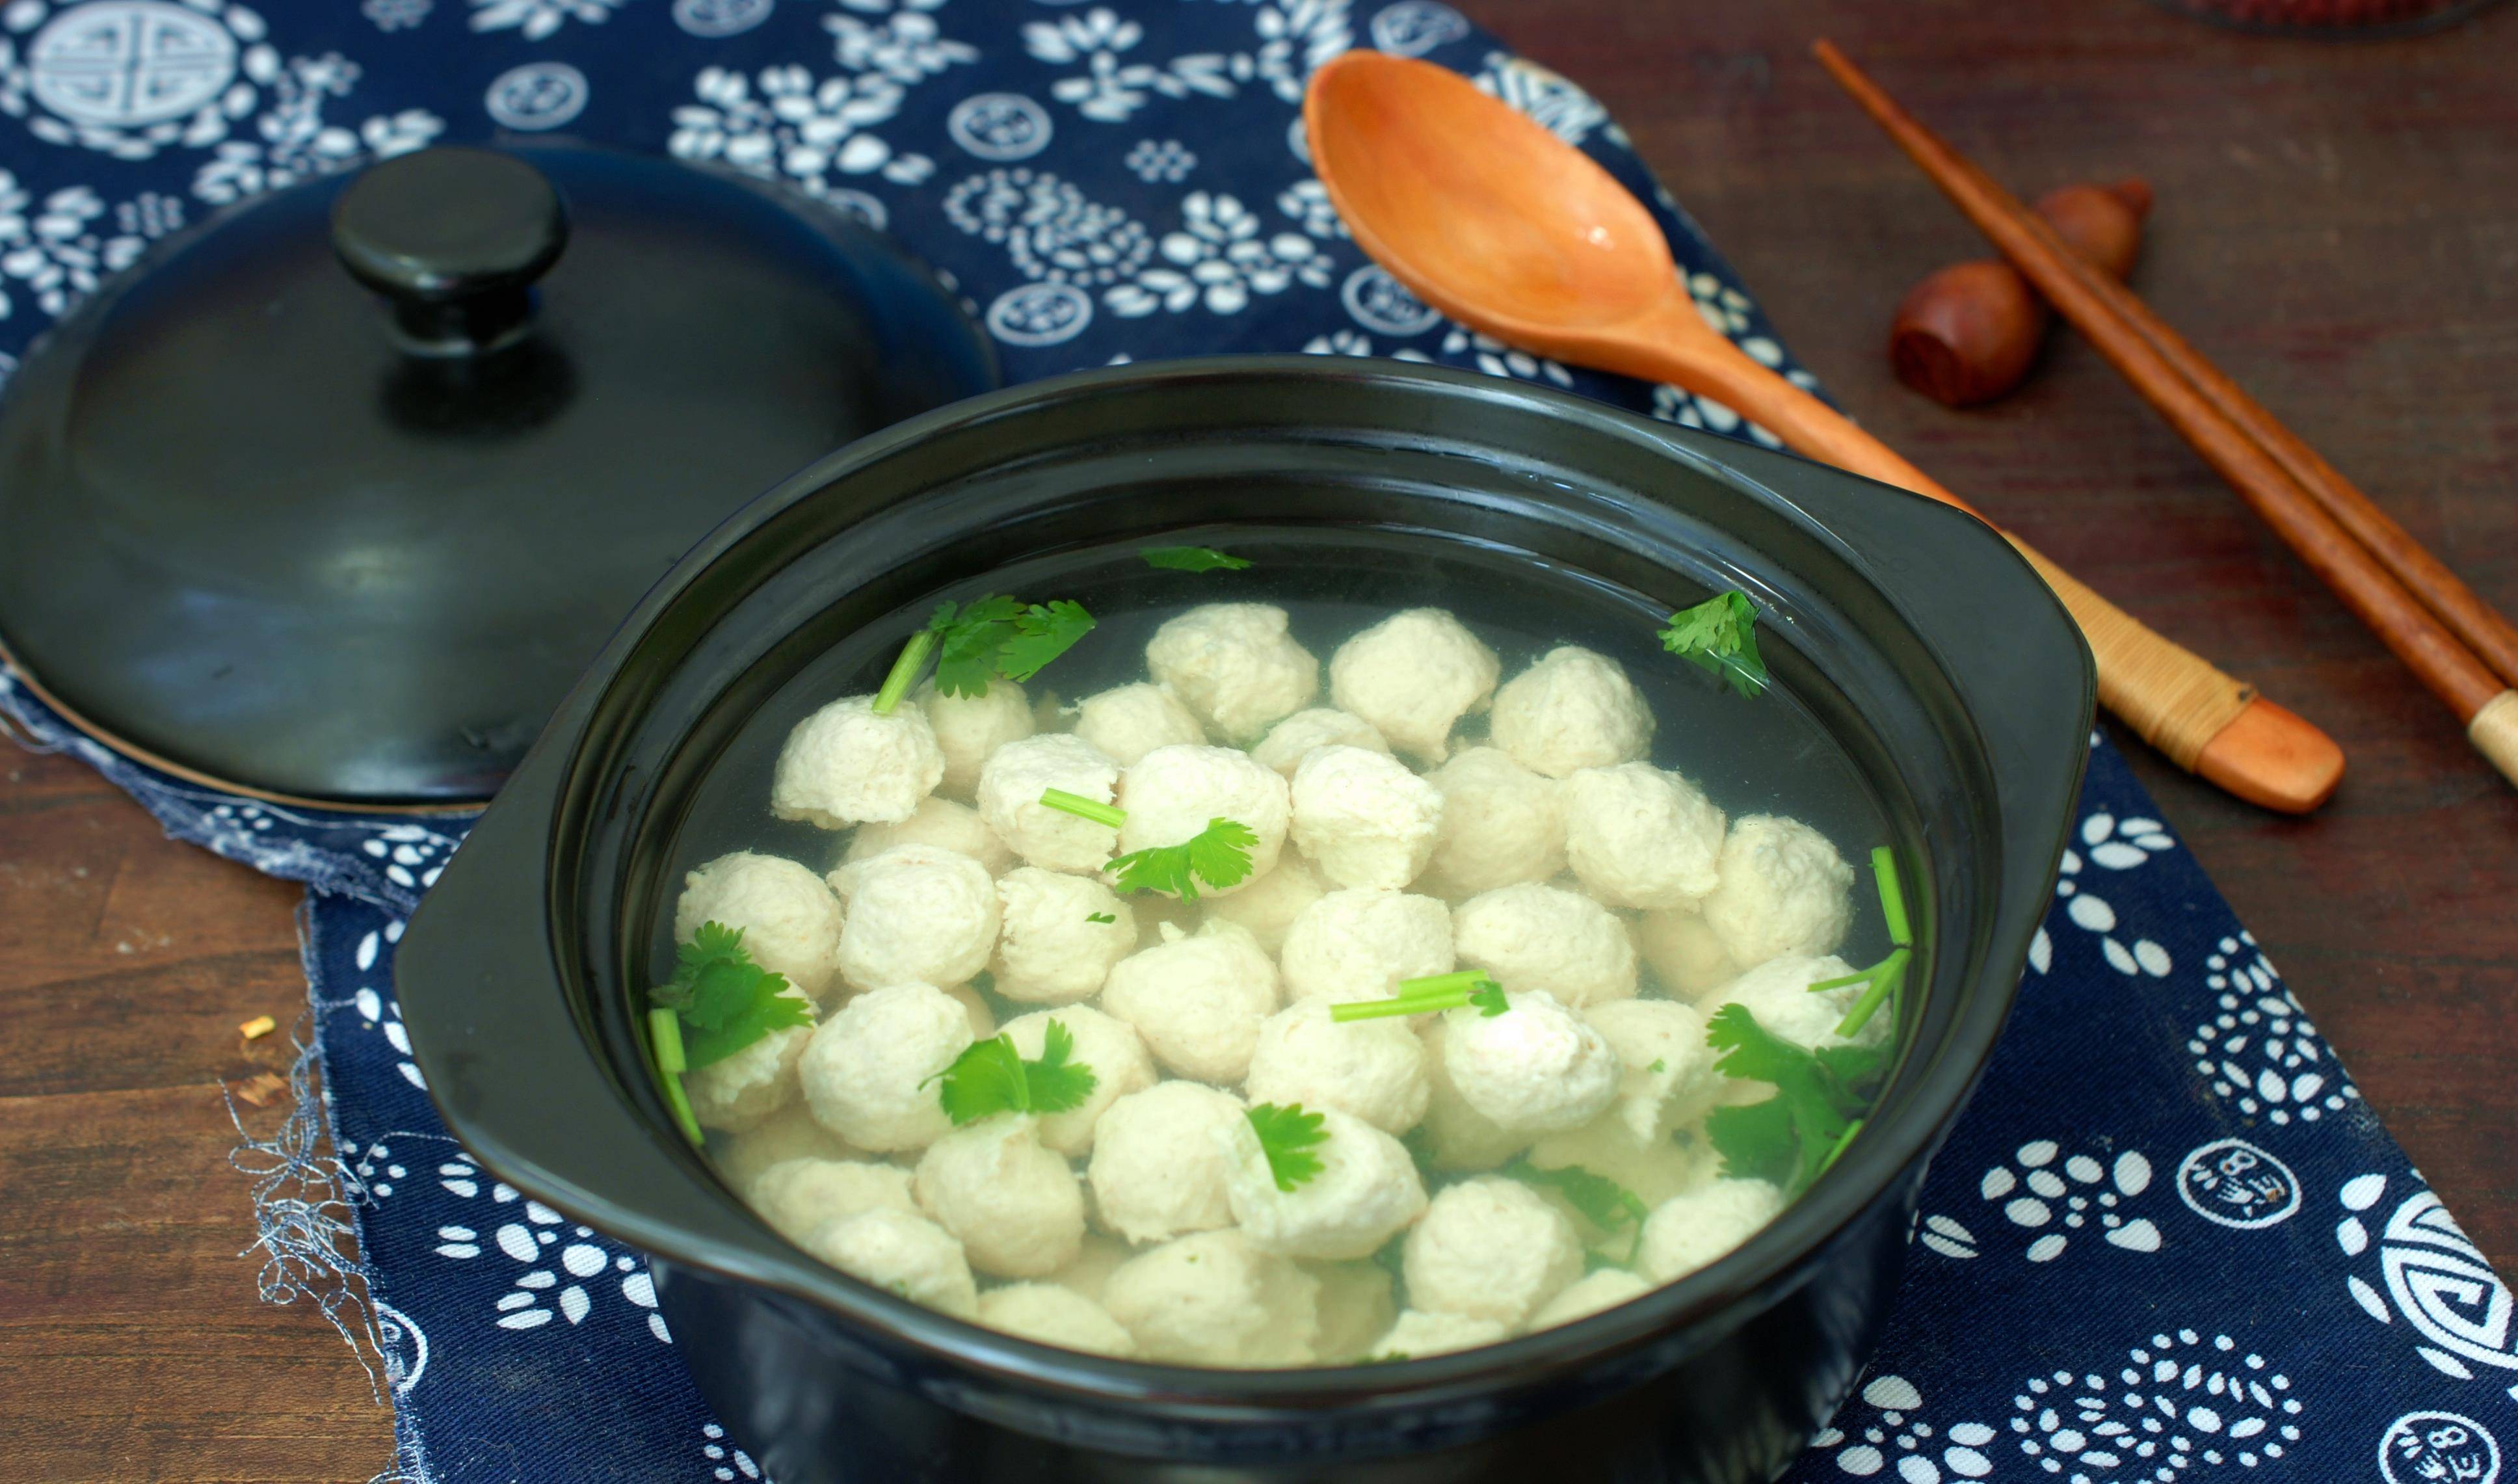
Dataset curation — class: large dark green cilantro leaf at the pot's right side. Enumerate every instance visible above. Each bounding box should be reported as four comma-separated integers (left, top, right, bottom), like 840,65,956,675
1704,1003,1886,1194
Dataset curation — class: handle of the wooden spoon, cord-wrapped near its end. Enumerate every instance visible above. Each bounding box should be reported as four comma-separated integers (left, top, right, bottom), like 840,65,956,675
1657,340,2344,814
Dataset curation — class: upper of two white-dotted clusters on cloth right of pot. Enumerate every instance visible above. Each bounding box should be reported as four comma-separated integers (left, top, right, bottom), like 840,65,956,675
2186,933,2359,1126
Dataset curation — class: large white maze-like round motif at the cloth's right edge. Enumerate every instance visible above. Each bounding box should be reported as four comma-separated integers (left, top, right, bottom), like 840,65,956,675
2334,1174,2518,1398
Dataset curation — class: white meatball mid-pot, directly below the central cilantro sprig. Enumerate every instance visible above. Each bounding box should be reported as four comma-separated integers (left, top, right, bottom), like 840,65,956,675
1100,922,1277,1083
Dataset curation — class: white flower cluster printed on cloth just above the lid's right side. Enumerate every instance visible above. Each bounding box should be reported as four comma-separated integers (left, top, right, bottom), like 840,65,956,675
667,66,934,194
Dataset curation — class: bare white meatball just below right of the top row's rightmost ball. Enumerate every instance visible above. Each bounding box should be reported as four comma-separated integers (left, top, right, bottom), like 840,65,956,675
1566,763,1725,907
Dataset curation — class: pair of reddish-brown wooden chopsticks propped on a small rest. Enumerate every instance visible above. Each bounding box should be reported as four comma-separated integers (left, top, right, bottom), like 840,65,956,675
1813,40,2518,784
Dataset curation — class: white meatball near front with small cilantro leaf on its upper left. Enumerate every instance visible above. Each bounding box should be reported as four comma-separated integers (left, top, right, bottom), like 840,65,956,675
1221,1109,1425,1262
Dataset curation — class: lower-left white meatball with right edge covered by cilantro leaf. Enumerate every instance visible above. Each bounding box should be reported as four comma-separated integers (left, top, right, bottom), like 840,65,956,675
801,985,974,1154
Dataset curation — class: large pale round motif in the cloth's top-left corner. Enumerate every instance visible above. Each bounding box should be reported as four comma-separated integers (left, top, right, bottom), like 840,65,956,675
25,0,237,129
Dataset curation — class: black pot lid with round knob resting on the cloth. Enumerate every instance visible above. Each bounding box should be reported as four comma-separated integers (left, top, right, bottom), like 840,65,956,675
0,149,997,806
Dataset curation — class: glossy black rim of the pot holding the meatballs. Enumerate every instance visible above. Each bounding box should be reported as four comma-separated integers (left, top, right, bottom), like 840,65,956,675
403,355,2095,1421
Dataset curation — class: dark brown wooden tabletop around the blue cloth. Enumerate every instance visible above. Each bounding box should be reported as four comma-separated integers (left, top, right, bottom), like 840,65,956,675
0,0,2518,1484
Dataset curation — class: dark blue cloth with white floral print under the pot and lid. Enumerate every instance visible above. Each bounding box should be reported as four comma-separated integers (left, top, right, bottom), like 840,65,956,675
0,0,2518,1484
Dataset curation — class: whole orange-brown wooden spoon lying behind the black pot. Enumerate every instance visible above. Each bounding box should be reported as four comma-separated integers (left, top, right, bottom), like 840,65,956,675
1302,50,2344,814
